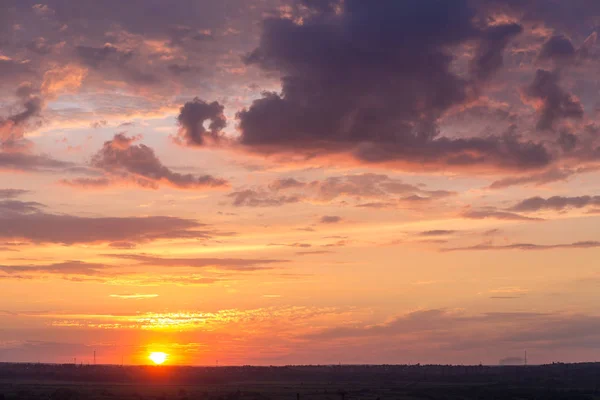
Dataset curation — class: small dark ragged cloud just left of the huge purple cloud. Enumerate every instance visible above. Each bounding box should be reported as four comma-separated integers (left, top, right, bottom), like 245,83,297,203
177,97,227,146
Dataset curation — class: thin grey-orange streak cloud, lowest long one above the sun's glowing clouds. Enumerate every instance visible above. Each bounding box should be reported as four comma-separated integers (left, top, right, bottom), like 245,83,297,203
109,254,287,271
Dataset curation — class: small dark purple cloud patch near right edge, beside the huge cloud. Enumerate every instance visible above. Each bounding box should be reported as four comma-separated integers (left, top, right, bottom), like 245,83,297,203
524,69,583,130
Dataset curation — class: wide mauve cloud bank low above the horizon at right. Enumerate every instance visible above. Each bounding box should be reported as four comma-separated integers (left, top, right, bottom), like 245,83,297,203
302,309,600,353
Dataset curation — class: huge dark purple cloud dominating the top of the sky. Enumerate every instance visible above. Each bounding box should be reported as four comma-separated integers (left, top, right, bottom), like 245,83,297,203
231,0,551,169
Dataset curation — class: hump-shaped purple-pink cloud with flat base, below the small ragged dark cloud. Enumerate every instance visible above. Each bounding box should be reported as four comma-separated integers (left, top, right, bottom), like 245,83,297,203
62,133,228,190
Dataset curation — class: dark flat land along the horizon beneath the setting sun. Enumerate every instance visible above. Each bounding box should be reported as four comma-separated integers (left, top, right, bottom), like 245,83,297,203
0,364,600,400
